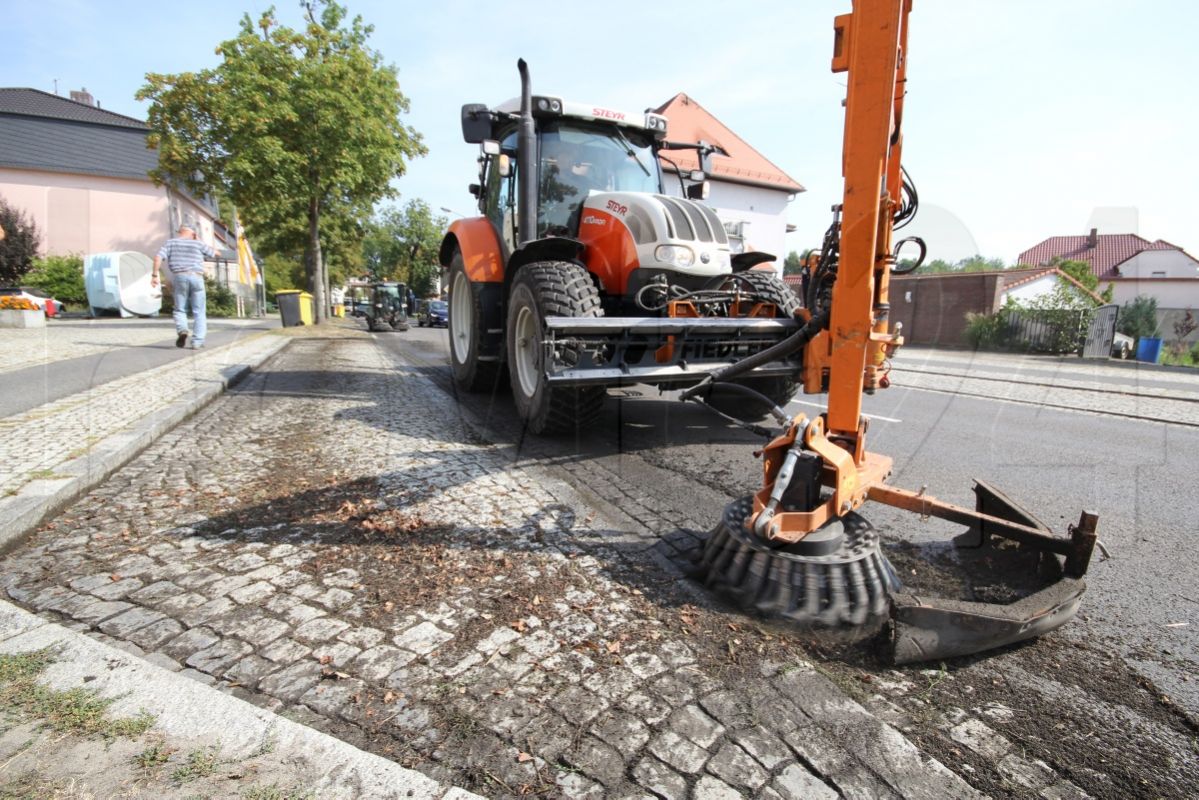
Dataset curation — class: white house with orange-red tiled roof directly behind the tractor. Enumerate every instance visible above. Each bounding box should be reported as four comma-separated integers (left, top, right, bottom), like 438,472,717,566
656,92,803,271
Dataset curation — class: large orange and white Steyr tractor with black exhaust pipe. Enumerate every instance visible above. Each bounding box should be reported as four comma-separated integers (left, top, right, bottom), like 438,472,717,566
440,61,802,433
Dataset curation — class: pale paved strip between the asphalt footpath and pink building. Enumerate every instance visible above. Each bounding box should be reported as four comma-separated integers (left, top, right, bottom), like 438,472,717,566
0,314,261,374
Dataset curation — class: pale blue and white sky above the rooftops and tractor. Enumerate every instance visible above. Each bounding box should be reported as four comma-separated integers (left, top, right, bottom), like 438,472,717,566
0,0,1199,260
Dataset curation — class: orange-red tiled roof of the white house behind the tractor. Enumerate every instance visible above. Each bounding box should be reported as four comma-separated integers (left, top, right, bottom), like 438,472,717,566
657,92,803,192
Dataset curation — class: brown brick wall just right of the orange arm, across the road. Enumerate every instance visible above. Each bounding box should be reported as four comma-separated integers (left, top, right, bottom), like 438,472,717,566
890,272,1004,347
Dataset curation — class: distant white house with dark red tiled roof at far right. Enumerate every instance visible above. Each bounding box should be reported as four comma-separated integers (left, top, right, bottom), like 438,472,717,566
1019,228,1199,308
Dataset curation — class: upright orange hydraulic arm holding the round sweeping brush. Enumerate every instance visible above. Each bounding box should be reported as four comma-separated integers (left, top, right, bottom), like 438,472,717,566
754,0,911,541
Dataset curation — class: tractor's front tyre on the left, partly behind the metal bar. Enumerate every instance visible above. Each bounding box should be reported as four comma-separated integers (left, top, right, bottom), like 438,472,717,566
507,261,607,433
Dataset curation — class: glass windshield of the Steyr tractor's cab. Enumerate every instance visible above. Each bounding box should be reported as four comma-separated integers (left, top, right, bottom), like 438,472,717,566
537,121,662,236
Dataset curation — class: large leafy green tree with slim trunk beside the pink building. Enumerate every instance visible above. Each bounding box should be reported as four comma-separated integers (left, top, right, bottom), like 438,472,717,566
138,0,426,323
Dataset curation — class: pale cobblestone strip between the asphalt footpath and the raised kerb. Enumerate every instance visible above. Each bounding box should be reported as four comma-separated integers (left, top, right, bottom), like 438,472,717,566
0,329,285,497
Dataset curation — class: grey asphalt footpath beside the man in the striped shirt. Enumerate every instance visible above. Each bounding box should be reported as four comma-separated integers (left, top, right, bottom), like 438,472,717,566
0,318,279,419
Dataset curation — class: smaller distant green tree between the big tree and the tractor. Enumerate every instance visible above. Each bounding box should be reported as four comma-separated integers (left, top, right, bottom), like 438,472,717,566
362,199,448,297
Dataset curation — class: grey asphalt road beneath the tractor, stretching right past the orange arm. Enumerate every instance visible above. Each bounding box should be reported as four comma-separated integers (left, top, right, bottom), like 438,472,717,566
376,327,1199,720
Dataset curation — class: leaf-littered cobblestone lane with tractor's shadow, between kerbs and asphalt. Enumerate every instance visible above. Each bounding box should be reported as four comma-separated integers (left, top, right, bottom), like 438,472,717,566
0,339,1007,799
